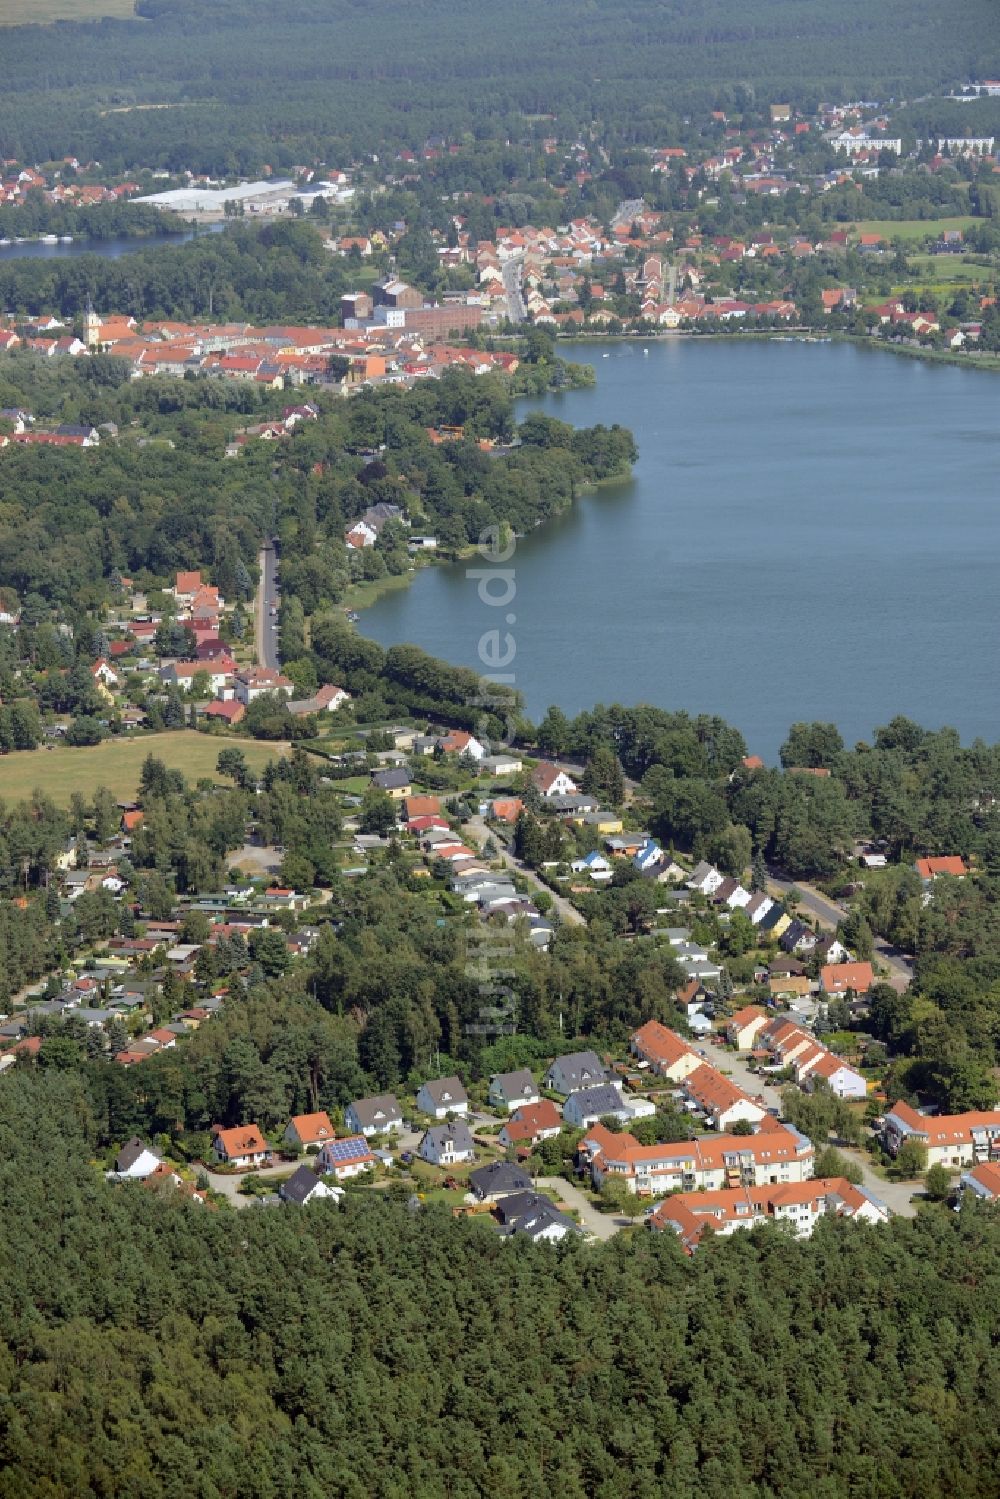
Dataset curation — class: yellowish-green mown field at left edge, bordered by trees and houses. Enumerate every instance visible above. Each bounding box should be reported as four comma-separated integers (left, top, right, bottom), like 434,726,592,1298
0,729,288,806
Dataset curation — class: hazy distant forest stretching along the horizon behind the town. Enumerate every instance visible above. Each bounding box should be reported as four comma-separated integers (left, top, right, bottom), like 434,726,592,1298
0,0,1000,174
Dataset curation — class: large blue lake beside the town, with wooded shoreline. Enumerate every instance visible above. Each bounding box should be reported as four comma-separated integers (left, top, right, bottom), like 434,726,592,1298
361,339,1000,760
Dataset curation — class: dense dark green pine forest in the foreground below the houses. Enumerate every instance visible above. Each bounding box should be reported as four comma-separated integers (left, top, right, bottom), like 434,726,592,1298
0,1070,1000,1499
